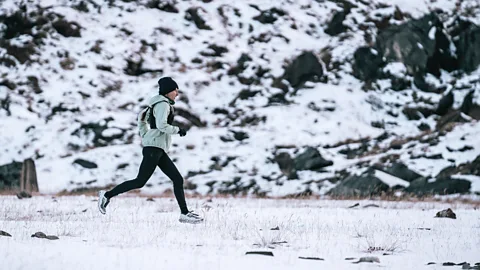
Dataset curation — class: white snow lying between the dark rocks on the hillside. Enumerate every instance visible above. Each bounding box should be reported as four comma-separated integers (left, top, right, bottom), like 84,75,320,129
0,0,480,196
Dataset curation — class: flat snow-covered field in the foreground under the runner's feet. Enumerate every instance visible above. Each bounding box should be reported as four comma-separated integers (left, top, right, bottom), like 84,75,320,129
0,196,480,270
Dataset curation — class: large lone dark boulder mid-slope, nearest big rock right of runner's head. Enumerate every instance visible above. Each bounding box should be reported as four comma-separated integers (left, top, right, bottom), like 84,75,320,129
282,52,323,89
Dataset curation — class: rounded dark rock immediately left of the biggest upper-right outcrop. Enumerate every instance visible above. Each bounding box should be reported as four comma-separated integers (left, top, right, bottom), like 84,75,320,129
352,47,384,81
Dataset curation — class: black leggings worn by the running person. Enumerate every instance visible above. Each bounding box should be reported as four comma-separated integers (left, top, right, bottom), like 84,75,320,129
105,146,188,214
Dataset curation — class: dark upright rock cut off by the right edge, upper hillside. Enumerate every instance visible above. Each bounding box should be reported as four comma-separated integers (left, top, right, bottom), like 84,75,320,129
455,23,480,72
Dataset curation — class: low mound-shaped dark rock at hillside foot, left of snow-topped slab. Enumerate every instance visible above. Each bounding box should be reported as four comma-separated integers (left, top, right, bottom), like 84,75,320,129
327,170,389,197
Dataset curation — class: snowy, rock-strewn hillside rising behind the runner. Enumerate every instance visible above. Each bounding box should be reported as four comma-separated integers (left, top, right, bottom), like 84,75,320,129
0,0,480,196
